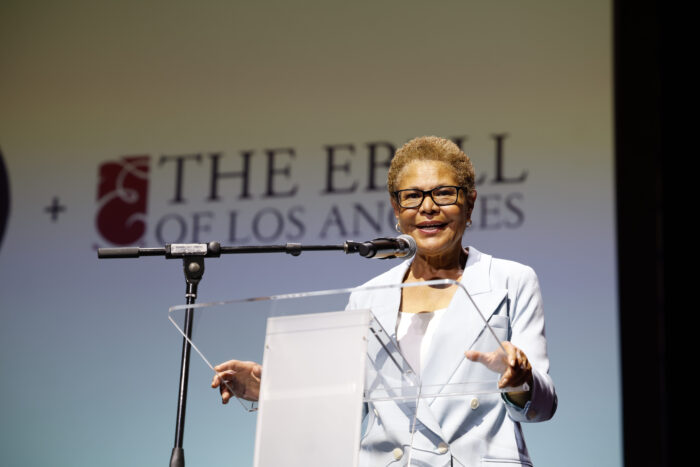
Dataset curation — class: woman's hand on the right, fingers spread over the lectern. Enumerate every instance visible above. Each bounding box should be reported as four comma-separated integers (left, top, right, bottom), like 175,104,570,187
464,341,532,399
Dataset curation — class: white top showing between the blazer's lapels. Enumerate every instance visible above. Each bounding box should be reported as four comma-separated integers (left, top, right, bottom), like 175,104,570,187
396,308,447,376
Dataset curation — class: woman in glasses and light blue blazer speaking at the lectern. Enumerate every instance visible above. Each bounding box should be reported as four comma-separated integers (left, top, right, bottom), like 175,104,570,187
212,136,557,467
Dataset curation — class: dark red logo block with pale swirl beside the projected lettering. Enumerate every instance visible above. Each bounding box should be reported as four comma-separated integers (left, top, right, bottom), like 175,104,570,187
95,156,148,245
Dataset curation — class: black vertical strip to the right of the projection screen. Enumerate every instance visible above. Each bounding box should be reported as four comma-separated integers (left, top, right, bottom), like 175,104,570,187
616,0,698,466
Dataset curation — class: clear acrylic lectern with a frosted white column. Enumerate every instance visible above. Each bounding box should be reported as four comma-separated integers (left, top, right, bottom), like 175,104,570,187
169,280,516,467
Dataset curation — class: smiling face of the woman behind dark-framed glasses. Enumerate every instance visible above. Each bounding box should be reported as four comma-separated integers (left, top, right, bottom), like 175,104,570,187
391,160,476,264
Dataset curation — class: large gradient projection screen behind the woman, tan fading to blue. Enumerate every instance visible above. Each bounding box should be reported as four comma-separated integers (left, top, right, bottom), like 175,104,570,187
0,0,622,466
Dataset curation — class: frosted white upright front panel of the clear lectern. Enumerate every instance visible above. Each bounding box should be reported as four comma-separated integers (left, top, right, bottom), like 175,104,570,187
254,310,371,467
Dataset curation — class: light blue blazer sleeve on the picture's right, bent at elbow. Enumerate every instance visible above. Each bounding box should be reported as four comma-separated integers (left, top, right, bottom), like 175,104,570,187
504,266,557,422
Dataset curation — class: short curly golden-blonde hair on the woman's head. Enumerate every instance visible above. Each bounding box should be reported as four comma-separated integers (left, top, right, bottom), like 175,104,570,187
387,136,475,197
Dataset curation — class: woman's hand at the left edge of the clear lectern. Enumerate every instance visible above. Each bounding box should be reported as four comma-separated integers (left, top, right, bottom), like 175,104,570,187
211,360,262,404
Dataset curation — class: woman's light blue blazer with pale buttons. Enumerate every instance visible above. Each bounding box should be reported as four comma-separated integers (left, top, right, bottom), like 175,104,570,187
348,247,557,467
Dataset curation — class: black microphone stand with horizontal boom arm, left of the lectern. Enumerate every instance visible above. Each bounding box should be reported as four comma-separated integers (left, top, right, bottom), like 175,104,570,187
97,242,358,467
